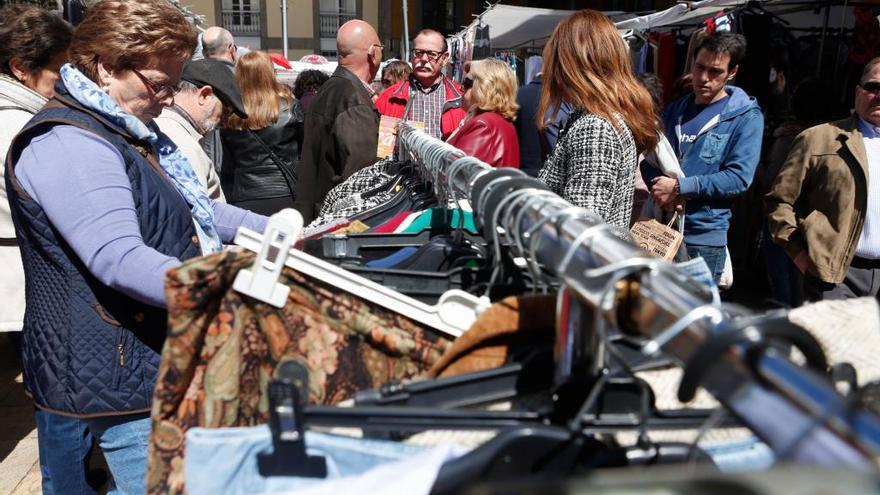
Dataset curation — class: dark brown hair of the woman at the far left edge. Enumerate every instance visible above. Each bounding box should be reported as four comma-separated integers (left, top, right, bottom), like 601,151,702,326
0,4,73,76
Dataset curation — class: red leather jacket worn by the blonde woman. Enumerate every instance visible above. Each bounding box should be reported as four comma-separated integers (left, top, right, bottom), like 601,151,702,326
447,112,519,168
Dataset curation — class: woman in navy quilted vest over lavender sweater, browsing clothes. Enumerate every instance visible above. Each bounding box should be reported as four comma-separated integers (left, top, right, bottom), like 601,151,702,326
5,0,265,494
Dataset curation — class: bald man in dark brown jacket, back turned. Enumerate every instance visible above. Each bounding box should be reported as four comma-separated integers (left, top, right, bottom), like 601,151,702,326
296,19,384,223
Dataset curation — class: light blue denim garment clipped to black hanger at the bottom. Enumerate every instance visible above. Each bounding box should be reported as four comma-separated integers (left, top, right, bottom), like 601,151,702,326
184,425,460,495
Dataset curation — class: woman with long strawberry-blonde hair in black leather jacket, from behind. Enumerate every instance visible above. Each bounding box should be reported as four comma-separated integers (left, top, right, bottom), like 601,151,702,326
220,51,302,215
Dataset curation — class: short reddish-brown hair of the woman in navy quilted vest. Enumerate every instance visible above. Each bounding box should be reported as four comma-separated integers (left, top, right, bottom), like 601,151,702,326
70,0,196,81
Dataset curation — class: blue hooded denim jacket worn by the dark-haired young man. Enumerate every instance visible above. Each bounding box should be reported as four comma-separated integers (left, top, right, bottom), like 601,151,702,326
660,86,764,246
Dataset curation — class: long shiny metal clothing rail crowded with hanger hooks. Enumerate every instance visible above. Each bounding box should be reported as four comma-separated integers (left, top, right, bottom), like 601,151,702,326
399,123,880,466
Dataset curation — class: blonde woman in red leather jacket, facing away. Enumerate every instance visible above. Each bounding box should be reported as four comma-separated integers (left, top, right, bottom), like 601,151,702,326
447,59,519,168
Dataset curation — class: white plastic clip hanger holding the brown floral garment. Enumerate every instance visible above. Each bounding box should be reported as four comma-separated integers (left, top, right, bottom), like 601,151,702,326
233,208,490,337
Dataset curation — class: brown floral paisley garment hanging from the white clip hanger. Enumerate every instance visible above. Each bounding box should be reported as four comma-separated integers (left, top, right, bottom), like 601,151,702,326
147,248,450,494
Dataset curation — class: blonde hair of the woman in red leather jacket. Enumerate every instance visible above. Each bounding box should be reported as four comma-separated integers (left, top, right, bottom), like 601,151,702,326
464,58,519,120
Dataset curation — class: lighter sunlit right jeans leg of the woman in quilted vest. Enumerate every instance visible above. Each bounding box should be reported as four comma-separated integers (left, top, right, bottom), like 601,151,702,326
83,414,152,495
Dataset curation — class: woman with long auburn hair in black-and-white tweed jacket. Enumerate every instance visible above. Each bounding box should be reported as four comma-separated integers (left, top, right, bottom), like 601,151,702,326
538,10,660,228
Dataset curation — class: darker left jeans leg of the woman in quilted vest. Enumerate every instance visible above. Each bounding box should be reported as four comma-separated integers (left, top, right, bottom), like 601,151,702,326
34,409,95,495
